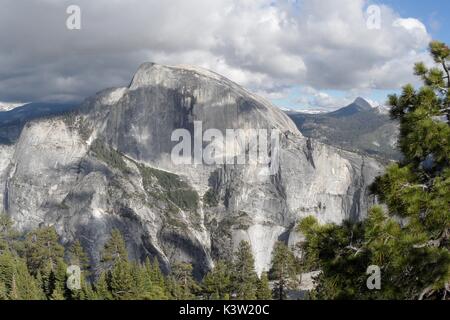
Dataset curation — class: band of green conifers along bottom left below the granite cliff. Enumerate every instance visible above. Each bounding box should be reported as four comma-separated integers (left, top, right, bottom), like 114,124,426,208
0,216,282,300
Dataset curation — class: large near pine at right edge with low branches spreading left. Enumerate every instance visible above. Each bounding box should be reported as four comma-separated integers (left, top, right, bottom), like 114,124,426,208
301,41,450,299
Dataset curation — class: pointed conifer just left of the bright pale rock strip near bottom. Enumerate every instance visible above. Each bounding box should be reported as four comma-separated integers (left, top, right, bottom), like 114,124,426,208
232,241,258,300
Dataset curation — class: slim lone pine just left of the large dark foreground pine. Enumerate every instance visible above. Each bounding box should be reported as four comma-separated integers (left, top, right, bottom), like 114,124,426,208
270,242,298,300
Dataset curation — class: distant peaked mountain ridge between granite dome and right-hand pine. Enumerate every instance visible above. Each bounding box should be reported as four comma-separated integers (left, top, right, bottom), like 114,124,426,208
285,98,401,160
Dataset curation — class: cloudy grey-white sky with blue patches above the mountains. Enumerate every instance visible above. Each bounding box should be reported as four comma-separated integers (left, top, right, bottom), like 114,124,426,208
0,0,450,111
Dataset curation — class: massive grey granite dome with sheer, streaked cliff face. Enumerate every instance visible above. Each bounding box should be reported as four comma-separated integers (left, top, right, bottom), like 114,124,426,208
0,63,382,276
